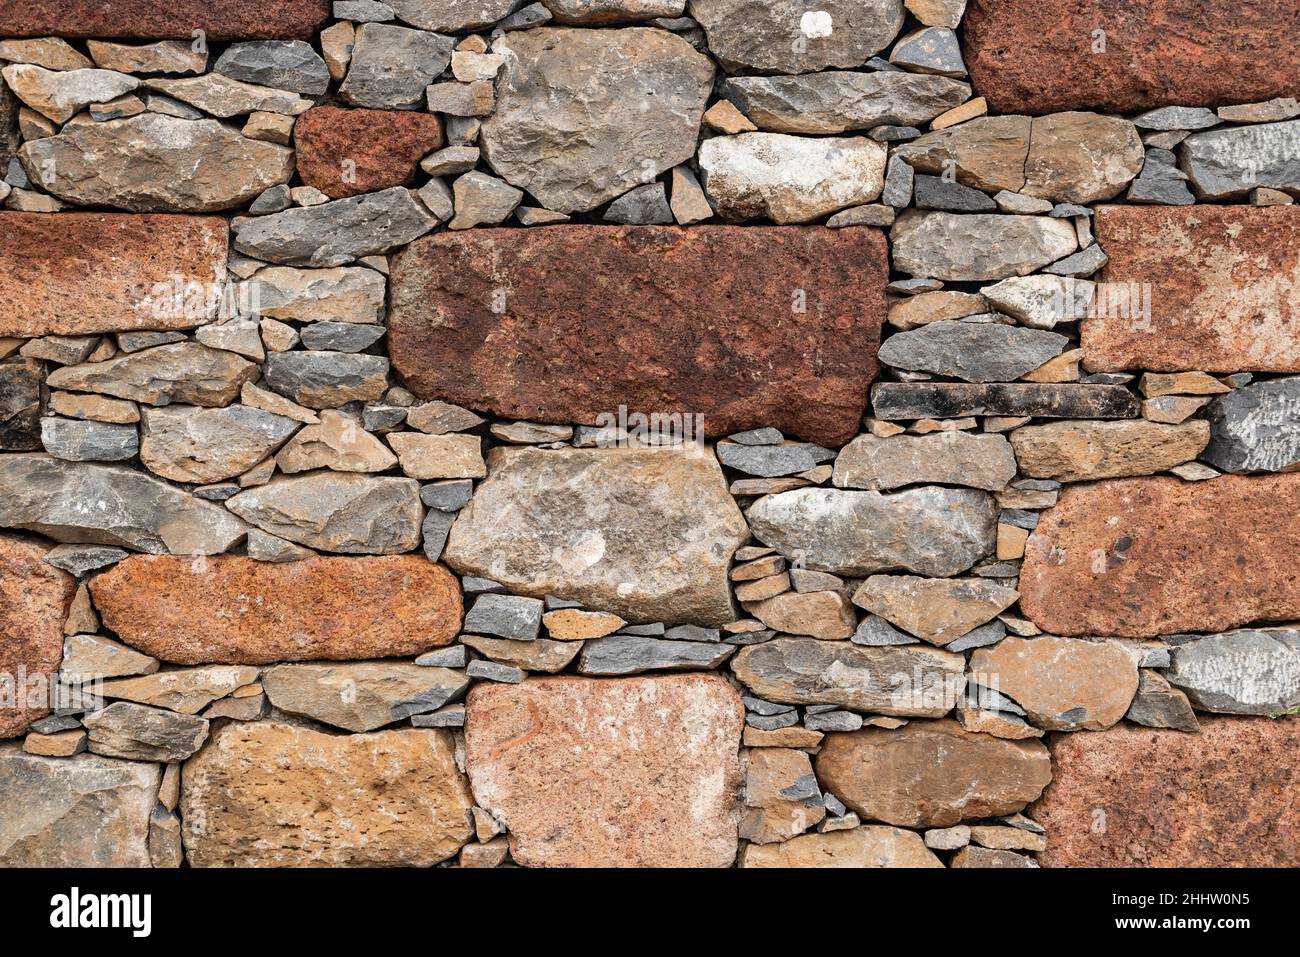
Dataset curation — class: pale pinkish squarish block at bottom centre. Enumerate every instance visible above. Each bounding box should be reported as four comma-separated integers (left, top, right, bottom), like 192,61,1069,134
465,675,745,867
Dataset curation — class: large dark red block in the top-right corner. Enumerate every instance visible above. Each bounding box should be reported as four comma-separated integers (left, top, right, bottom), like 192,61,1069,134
963,0,1300,113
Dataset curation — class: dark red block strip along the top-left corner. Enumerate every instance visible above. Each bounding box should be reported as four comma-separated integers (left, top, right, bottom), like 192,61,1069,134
0,0,329,40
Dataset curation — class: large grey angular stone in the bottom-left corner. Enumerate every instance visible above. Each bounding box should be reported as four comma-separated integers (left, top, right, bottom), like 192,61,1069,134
0,742,161,867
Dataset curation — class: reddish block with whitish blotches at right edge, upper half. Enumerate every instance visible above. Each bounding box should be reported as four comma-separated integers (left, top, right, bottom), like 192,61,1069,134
1080,205,1300,372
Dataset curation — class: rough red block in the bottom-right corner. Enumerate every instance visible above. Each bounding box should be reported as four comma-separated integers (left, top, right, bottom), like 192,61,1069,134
1028,718,1300,867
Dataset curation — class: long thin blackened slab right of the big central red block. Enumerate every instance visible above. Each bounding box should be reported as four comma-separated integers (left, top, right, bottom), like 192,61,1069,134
871,382,1141,419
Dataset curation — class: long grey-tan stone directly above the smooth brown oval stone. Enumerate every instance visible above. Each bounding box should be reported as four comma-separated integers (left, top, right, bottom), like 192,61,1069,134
733,638,966,718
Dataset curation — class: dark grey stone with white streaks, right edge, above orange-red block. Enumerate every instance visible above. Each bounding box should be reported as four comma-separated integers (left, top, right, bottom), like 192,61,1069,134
1200,377,1300,472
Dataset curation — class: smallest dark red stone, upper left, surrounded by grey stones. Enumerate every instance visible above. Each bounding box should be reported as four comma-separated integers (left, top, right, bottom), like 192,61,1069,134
294,107,442,199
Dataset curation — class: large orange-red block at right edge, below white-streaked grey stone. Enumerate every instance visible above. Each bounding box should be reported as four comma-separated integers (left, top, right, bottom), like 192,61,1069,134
1021,475,1300,638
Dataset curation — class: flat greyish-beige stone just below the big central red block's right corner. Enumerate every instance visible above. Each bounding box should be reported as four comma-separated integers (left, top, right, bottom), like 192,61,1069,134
832,432,1015,492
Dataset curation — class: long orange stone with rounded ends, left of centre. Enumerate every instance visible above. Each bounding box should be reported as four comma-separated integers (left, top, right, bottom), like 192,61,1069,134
91,555,462,664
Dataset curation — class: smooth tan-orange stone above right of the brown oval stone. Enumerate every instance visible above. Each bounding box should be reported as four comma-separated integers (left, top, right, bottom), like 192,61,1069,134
970,636,1138,731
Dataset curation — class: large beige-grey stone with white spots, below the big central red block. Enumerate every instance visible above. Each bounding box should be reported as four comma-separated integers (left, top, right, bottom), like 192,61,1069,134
443,446,749,627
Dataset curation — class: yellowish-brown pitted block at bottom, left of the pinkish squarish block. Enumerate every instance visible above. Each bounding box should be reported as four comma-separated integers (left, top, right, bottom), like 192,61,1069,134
181,722,473,867
